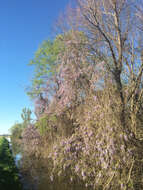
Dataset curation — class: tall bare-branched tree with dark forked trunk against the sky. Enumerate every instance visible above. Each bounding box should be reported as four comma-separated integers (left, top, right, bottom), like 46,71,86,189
78,0,143,135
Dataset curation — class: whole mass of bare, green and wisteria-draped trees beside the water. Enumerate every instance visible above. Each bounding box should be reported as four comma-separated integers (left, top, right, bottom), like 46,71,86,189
13,0,143,190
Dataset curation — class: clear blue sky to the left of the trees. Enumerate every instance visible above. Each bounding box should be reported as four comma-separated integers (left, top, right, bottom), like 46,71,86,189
0,0,69,134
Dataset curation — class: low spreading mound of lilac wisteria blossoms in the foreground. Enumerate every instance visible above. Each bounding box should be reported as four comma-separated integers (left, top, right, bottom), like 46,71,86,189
50,91,134,189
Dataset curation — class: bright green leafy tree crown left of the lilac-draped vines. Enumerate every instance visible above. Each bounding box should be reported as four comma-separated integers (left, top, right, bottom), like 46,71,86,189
27,35,64,99
